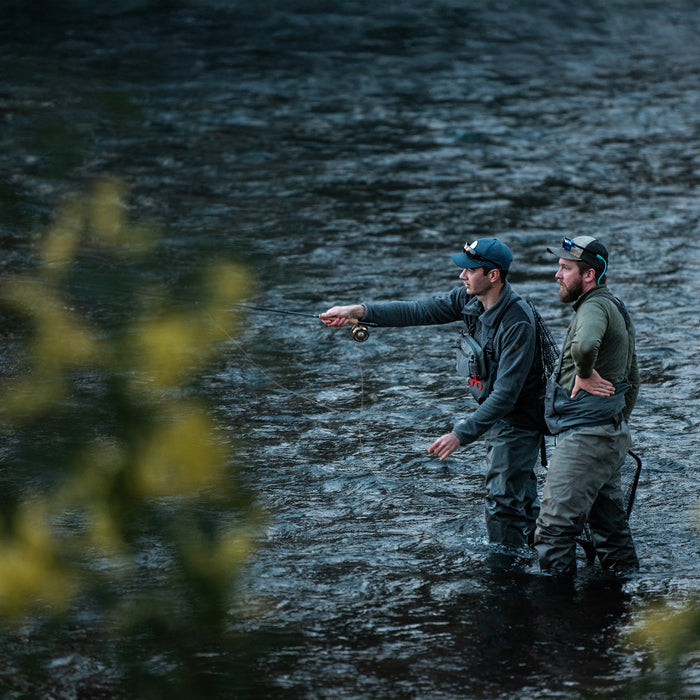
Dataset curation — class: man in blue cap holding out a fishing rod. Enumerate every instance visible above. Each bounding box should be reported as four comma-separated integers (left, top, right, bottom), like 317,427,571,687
320,238,543,547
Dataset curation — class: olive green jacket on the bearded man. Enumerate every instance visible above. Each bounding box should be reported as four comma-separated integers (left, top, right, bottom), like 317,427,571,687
559,284,639,419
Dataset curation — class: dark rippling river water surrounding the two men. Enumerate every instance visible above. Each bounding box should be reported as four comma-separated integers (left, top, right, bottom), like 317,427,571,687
0,0,700,699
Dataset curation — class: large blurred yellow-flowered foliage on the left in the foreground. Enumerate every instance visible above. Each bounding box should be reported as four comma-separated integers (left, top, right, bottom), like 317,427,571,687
0,181,258,698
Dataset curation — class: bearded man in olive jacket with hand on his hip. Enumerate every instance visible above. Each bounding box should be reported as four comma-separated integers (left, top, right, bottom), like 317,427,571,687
535,236,639,577
